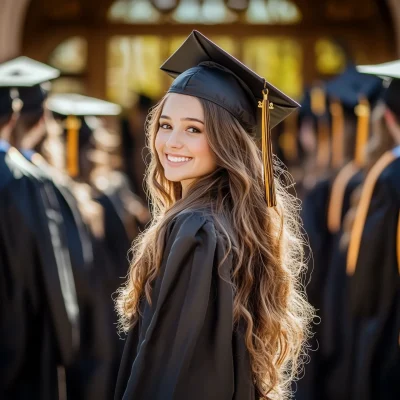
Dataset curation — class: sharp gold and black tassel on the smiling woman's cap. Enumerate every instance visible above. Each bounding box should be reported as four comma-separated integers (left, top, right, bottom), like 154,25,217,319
258,89,276,207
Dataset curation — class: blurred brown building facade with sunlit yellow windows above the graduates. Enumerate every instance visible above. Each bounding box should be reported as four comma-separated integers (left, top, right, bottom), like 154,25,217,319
0,0,398,108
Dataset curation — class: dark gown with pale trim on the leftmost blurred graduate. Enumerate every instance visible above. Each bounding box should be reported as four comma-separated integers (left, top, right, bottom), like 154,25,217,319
0,149,78,400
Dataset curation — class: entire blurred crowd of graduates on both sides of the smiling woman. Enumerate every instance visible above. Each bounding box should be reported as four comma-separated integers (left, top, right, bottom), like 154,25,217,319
0,57,400,400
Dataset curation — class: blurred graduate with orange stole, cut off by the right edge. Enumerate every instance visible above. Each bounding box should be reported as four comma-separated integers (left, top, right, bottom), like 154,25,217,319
340,61,400,400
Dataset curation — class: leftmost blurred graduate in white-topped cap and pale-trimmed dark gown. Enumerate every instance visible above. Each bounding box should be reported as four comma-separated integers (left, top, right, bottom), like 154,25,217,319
0,57,80,399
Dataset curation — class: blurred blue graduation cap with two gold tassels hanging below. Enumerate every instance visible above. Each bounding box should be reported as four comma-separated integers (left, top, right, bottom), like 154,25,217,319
325,65,382,168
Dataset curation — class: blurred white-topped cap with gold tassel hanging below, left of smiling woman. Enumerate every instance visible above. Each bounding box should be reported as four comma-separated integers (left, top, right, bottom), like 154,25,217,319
47,93,121,177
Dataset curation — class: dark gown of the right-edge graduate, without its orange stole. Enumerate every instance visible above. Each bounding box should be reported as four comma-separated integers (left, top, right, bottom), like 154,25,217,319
349,158,400,400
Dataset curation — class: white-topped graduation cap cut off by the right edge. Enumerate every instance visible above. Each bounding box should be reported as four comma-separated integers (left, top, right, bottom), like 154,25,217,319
357,60,400,118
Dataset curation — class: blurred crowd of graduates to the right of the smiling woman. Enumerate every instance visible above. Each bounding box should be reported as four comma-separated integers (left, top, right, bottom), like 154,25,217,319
288,61,400,400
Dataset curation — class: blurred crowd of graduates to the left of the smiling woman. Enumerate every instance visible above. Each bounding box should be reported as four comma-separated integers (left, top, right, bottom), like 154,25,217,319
0,57,150,400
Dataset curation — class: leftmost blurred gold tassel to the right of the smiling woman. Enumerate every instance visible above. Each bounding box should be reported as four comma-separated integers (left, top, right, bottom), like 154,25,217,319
310,86,330,169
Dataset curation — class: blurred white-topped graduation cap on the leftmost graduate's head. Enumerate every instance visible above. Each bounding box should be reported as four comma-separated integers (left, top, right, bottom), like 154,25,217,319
0,57,60,113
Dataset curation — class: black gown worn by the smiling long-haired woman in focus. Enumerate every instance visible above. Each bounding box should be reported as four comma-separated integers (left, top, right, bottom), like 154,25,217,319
115,211,255,400
